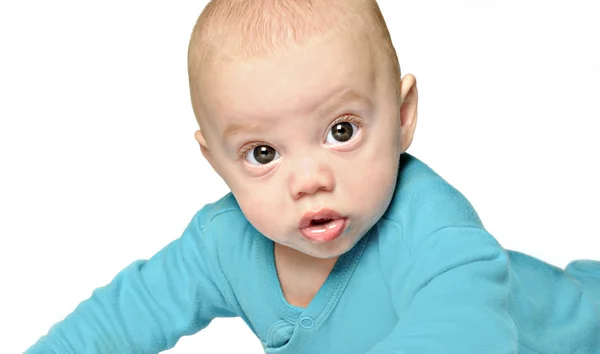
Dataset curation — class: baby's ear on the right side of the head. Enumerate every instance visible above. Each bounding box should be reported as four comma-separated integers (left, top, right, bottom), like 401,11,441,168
400,74,419,152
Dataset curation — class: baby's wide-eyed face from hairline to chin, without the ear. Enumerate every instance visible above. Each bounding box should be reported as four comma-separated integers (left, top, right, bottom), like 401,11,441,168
196,34,410,258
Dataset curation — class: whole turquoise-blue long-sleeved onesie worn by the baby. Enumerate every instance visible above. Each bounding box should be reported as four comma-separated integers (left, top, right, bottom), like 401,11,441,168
26,154,600,354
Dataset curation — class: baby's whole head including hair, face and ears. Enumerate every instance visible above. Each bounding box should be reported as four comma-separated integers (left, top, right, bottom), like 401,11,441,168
189,0,417,258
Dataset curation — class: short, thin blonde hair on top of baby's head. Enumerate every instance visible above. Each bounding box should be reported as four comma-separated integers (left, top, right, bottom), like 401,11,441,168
188,0,400,124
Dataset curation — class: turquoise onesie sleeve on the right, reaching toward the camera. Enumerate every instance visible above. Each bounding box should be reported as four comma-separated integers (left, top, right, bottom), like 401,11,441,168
368,227,517,354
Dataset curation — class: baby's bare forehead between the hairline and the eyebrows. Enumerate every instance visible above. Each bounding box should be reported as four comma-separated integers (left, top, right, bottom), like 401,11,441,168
198,39,377,125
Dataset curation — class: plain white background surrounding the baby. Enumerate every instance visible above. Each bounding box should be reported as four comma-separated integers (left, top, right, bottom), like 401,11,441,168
0,0,600,353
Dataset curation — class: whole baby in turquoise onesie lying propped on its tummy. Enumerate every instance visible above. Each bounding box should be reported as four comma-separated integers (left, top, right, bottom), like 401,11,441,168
27,0,600,354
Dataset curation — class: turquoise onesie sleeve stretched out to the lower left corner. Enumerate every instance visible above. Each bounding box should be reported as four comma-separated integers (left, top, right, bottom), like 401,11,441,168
25,213,236,354
